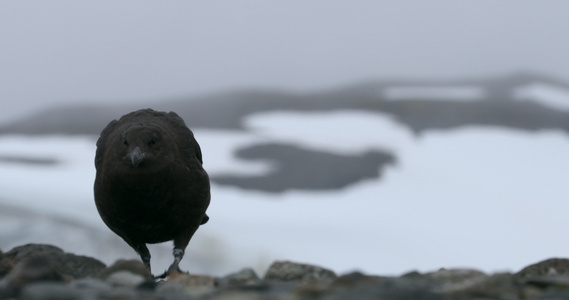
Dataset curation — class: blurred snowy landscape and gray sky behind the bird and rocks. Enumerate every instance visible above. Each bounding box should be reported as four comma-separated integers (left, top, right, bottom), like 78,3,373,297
0,0,569,275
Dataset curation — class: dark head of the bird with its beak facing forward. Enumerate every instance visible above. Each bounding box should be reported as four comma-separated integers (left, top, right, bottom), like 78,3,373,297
120,126,174,169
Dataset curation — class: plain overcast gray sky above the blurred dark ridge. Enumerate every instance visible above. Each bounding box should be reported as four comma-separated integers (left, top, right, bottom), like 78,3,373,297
0,0,569,122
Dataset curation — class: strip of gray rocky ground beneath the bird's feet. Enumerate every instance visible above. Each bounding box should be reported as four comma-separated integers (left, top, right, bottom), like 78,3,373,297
0,244,569,300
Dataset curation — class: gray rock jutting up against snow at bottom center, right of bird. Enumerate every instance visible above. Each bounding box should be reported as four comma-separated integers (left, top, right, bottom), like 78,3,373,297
264,261,337,281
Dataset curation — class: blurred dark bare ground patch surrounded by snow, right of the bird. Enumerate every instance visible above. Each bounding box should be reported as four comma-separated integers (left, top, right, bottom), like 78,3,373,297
211,144,395,192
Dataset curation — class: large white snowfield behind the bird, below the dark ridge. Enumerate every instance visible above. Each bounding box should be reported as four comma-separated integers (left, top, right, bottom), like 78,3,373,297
0,111,569,275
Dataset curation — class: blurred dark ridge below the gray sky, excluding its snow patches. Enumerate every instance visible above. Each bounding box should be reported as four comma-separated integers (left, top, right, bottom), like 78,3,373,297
0,72,569,134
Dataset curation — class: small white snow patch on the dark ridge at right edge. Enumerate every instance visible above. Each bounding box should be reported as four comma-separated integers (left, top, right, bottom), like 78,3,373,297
513,83,569,111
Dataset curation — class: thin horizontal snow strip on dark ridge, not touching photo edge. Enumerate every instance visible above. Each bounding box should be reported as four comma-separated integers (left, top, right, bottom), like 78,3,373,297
382,85,486,101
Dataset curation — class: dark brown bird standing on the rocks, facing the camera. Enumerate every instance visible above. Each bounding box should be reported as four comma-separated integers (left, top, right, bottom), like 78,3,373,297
94,109,210,277
